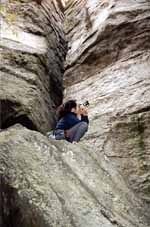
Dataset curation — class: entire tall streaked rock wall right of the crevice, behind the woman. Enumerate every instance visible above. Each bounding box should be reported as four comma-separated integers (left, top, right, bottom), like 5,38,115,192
64,0,150,222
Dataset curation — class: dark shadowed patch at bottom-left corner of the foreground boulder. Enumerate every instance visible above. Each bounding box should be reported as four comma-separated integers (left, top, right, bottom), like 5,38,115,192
0,175,49,227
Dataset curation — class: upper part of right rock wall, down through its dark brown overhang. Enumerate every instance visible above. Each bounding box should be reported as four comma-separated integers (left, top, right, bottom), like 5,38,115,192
65,0,150,85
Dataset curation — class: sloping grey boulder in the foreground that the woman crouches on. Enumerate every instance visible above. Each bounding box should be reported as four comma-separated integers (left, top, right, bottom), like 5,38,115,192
0,125,149,227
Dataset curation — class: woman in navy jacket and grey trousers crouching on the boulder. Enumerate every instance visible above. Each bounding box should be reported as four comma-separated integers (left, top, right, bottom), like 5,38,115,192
54,100,89,143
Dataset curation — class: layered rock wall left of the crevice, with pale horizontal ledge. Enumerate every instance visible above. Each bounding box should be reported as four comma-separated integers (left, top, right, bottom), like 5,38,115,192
0,0,66,132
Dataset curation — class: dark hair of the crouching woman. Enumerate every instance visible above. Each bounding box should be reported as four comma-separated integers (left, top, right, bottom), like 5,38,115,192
56,99,77,119
